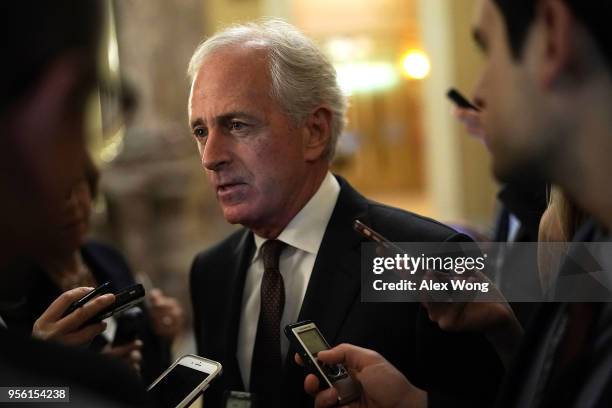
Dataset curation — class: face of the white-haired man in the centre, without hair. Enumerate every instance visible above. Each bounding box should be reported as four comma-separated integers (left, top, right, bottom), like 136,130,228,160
189,46,316,229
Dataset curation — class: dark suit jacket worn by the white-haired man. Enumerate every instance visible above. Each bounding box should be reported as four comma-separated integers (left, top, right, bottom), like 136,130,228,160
191,177,502,408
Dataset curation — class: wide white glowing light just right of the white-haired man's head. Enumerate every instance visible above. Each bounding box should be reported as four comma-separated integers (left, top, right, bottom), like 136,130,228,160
335,61,398,95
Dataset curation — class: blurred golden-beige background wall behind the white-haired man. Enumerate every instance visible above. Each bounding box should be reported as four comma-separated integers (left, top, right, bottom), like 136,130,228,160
96,0,496,356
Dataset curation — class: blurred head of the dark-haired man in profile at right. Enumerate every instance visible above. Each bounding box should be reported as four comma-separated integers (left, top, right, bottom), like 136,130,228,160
474,0,612,189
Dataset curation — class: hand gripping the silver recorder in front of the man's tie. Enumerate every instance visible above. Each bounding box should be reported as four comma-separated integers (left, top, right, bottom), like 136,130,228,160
295,344,427,408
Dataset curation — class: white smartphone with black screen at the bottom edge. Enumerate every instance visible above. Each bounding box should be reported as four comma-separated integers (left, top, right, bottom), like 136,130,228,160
147,354,222,408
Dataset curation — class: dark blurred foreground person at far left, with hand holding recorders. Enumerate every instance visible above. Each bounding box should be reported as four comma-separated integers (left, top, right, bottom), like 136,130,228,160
0,0,146,407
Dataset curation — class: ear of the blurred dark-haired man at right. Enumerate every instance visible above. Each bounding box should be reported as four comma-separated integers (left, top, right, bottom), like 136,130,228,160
537,0,577,88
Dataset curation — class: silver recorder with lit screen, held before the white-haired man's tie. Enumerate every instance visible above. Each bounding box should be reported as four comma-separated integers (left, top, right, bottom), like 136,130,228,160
285,320,361,405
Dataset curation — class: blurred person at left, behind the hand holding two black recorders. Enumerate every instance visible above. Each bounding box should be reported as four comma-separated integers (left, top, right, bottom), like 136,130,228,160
4,158,183,384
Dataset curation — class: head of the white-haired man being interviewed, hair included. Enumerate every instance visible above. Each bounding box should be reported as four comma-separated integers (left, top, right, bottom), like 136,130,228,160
189,21,346,237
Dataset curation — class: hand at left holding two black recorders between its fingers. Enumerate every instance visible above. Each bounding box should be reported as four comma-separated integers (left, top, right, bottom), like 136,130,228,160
32,287,115,346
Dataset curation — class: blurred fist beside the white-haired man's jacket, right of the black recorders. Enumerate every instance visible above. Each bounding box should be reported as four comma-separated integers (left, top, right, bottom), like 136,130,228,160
149,289,184,340
